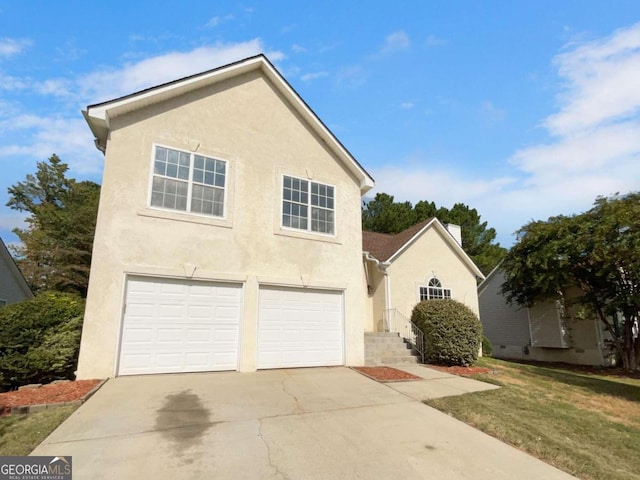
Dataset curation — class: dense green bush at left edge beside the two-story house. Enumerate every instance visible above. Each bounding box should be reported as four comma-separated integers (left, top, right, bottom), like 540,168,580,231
0,292,84,391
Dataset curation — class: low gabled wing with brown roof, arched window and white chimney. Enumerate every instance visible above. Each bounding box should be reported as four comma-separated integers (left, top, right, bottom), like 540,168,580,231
362,218,484,337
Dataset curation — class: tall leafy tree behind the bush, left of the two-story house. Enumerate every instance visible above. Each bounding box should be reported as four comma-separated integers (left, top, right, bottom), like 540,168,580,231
7,154,100,296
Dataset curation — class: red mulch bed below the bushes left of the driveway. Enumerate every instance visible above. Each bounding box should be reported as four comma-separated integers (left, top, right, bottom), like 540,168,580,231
0,380,101,416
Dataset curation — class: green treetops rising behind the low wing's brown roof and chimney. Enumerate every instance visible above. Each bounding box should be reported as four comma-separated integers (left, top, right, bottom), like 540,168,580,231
362,193,507,274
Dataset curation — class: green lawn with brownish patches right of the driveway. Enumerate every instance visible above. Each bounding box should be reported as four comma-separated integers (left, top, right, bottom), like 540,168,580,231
425,358,640,480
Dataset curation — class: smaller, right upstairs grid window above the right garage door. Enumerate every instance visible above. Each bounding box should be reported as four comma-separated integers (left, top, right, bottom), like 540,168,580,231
282,176,335,234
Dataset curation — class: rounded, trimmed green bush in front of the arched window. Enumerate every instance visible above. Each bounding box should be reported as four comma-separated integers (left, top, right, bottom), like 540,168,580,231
411,300,482,365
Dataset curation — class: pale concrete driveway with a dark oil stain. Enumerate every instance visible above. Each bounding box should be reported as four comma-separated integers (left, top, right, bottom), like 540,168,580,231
33,367,573,480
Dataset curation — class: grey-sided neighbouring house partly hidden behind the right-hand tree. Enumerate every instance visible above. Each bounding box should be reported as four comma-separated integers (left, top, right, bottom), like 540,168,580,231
478,266,611,366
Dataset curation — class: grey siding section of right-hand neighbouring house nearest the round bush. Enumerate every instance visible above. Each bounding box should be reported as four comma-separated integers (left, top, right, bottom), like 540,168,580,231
478,271,530,350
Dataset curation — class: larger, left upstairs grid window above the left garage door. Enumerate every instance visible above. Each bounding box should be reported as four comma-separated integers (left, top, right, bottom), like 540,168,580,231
151,146,227,217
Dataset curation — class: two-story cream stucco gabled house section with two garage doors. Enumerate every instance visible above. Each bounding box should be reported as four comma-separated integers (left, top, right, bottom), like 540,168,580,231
78,55,373,378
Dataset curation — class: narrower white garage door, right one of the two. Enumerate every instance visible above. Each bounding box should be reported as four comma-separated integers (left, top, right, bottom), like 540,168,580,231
258,287,344,368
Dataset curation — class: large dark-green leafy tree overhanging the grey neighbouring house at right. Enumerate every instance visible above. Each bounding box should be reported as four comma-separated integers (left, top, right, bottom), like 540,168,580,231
501,193,640,370
